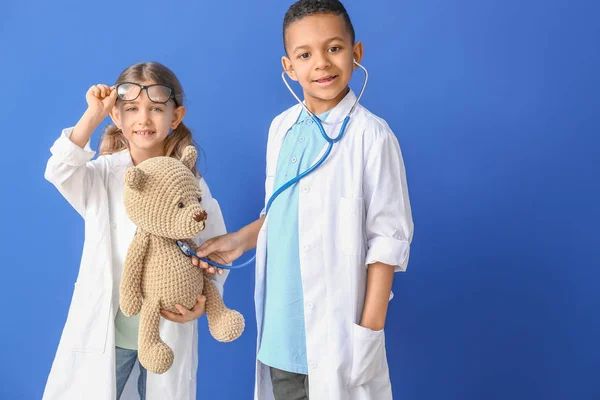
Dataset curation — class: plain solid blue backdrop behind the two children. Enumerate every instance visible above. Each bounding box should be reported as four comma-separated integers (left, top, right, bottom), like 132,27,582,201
0,0,600,400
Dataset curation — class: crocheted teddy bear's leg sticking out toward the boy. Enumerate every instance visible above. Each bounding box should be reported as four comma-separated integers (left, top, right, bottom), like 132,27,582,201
204,277,245,342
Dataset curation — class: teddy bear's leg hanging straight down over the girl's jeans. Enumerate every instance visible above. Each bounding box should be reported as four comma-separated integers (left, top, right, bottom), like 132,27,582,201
138,298,174,374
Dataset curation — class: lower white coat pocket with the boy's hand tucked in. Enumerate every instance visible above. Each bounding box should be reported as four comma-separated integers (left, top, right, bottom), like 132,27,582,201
348,324,385,387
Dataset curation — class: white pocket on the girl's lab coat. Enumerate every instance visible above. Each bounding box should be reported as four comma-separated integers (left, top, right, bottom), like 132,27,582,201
63,282,111,353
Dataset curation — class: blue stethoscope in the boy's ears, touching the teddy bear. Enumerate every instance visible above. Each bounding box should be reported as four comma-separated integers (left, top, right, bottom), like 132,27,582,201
177,60,369,269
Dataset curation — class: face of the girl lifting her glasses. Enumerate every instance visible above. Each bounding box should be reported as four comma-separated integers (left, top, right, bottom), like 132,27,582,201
111,82,185,164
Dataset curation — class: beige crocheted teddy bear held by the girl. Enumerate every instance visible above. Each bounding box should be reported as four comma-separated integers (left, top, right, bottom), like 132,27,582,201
120,146,245,374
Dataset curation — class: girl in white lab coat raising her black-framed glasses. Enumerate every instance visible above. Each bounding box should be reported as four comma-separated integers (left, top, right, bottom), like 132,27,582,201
44,62,227,400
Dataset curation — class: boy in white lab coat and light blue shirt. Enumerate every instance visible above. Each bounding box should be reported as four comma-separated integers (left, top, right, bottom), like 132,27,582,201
198,0,413,400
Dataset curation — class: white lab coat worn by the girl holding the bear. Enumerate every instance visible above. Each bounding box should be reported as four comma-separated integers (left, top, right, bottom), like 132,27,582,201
43,129,227,400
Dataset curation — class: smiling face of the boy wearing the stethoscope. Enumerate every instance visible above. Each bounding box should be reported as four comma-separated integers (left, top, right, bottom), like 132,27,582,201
281,14,363,114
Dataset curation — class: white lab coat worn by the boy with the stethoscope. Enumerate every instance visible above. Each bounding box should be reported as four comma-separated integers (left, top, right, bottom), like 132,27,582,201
255,91,413,400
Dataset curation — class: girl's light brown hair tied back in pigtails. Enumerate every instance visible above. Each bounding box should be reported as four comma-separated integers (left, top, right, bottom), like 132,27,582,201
100,62,198,174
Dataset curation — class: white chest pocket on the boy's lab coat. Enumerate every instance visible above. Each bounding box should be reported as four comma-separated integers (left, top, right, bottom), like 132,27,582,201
335,197,364,256
